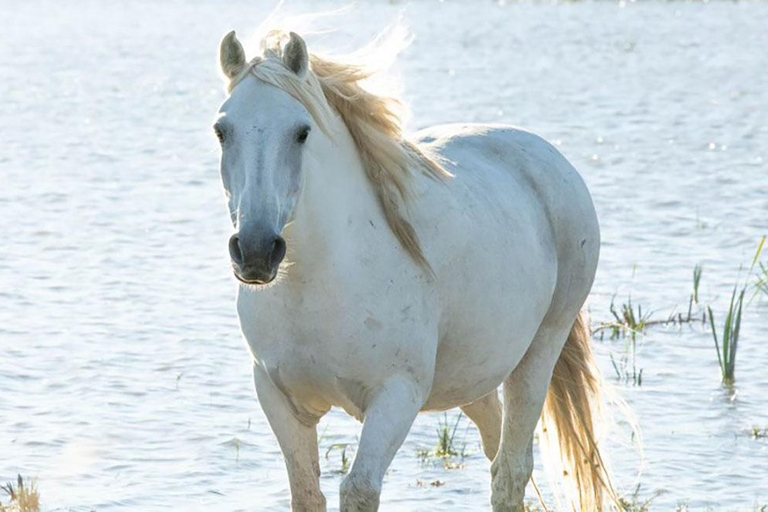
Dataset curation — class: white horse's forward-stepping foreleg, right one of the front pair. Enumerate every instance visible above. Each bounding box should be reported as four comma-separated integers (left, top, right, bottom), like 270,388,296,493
341,377,425,512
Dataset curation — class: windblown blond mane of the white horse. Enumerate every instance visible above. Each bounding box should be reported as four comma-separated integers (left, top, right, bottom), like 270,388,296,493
229,29,451,272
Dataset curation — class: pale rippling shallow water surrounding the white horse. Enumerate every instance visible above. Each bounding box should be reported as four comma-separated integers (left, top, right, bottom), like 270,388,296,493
0,0,768,511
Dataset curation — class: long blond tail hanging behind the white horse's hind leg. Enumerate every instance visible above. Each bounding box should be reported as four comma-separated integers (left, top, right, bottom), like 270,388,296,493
540,312,622,512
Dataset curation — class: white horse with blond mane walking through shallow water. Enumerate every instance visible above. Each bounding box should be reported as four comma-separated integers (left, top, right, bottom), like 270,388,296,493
214,30,615,512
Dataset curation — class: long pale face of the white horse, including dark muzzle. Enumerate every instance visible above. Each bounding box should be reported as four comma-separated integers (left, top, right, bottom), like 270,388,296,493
214,36,312,285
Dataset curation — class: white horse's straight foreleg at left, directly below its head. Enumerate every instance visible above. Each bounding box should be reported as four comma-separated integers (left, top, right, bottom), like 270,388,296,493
253,365,325,512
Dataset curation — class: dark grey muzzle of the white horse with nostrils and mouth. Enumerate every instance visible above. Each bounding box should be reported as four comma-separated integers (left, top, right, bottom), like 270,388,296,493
229,233,286,285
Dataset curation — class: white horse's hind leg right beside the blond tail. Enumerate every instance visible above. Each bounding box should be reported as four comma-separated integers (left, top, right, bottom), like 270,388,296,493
491,323,571,512
